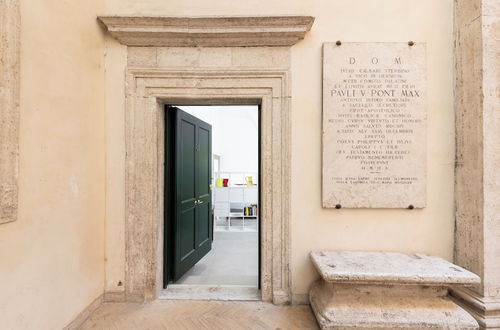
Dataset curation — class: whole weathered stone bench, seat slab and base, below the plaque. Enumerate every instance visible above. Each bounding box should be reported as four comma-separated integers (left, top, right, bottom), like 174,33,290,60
309,251,480,330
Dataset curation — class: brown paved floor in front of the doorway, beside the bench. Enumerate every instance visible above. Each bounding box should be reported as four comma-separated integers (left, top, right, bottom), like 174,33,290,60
81,300,318,330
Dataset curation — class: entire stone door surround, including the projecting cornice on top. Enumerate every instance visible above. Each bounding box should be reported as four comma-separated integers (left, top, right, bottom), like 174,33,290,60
98,16,314,304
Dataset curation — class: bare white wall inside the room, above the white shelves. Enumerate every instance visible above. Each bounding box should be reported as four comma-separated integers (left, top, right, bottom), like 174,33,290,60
178,105,259,178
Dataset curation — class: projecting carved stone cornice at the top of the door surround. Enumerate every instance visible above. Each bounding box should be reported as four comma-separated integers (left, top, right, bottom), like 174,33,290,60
98,16,314,47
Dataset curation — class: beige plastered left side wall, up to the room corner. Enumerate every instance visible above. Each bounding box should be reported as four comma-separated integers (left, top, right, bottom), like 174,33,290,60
0,0,105,329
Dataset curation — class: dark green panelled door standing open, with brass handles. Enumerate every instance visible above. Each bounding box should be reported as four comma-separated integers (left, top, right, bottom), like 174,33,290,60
173,109,212,281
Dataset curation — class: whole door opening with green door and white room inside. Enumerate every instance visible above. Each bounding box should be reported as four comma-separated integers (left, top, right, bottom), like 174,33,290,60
163,105,260,299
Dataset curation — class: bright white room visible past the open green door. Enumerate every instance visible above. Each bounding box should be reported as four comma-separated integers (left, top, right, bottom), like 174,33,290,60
167,105,259,290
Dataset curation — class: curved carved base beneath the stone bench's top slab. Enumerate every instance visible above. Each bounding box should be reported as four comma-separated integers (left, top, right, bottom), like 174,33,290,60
309,279,479,330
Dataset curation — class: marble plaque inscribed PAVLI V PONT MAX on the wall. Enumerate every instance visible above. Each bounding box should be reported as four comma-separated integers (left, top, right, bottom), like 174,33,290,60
323,42,426,208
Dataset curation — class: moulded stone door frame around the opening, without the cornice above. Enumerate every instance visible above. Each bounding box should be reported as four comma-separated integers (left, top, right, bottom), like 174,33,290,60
124,68,291,304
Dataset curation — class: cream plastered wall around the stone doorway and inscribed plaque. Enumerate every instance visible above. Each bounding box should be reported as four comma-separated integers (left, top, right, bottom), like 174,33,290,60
103,0,455,301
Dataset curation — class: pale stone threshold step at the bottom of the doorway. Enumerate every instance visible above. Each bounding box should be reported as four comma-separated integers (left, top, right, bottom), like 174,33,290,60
158,284,261,300
